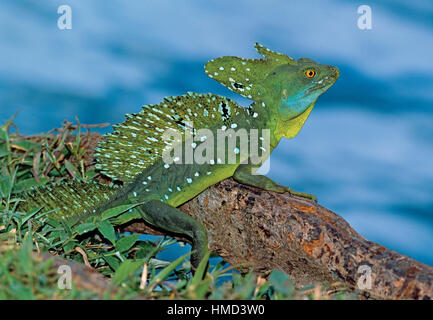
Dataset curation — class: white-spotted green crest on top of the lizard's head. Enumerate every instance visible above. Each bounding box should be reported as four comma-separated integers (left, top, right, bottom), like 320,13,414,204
205,43,297,101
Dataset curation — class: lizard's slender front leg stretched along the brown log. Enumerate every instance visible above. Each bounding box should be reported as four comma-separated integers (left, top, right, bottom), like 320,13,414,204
233,164,317,201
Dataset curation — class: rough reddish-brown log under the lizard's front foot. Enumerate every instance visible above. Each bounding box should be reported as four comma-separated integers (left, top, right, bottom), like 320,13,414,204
123,179,433,299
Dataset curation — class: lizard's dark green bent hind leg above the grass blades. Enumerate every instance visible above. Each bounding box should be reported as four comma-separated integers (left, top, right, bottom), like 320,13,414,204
137,200,208,271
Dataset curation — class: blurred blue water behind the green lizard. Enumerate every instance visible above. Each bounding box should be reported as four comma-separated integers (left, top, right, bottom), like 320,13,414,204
0,0,433,265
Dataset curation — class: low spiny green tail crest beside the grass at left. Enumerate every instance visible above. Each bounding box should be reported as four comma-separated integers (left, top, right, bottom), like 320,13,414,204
17,181,117,220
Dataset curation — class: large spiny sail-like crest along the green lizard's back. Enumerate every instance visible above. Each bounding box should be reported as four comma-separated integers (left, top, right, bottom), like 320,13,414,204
96,92,246,182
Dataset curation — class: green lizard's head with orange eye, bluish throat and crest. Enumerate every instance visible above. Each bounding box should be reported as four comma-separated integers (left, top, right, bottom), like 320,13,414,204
205,43,339,122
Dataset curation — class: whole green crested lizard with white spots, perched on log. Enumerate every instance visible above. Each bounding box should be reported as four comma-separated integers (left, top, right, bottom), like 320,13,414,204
18,44,339,268
